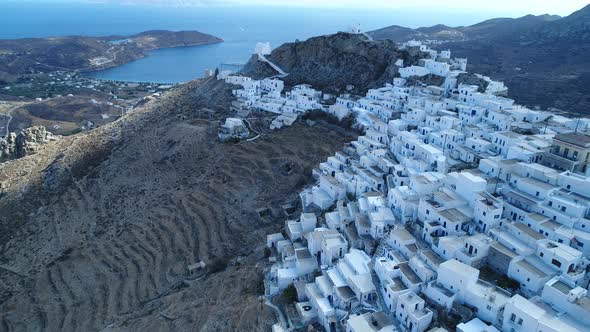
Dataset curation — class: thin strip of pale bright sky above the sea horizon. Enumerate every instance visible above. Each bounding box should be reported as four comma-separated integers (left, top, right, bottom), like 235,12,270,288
76,0,589,16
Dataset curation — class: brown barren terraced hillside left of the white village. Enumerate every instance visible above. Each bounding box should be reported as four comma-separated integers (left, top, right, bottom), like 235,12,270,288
0,81,353,331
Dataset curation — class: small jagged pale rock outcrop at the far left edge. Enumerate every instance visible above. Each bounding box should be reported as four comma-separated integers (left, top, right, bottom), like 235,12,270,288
0,126,57,161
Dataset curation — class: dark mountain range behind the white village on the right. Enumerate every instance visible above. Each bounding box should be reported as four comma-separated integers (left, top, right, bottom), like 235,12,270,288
369,5,590,115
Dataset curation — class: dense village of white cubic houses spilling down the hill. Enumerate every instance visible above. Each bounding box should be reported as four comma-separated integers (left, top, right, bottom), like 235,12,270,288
218,37,590,332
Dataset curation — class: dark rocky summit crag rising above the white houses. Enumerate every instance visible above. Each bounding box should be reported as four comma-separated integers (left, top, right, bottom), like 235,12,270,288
242,32,424,93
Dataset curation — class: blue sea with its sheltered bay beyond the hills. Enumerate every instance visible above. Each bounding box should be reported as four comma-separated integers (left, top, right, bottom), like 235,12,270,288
0,0,508,83
